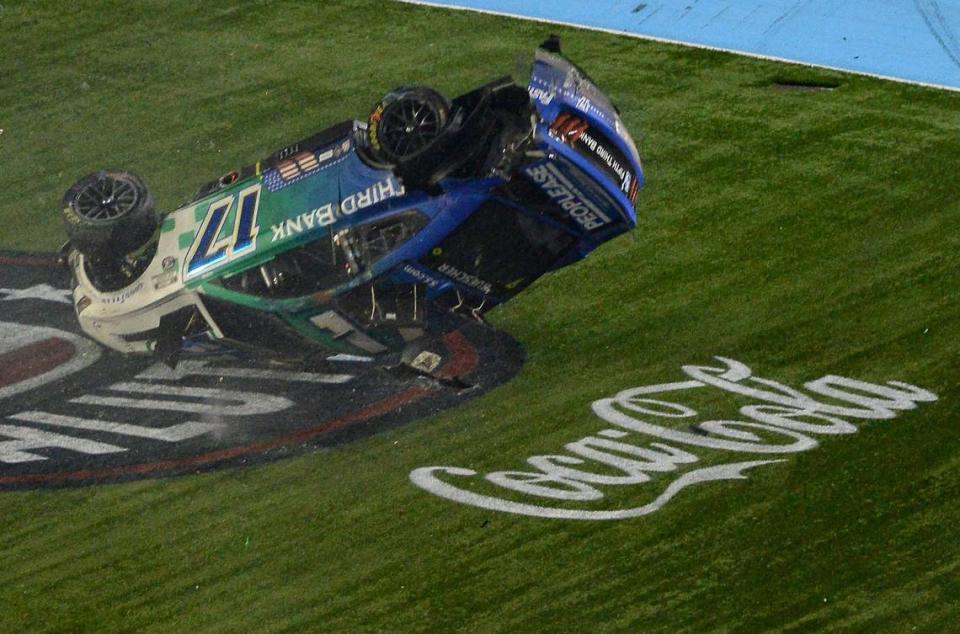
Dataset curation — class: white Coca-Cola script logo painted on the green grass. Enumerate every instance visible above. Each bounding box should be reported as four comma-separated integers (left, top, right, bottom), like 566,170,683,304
410,357,937,520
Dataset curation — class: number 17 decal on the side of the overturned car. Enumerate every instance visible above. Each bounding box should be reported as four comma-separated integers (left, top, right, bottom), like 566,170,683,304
184,184,260,279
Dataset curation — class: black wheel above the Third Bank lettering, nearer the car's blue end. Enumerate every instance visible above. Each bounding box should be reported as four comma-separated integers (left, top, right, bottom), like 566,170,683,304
367,86,450,164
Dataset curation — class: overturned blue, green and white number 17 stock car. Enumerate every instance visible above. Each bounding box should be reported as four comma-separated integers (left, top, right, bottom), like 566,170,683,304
63,39,643,370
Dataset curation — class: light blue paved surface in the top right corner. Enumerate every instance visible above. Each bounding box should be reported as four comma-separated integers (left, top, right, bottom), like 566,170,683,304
403,0,960,90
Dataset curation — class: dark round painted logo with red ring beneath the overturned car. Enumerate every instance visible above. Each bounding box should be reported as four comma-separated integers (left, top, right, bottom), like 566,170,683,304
0,253,523,490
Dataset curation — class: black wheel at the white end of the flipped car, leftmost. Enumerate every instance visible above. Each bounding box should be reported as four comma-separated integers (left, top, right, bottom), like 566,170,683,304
63,171,160,260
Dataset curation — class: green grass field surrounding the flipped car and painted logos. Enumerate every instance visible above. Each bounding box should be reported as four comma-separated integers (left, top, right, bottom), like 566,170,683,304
0,0,960,632
